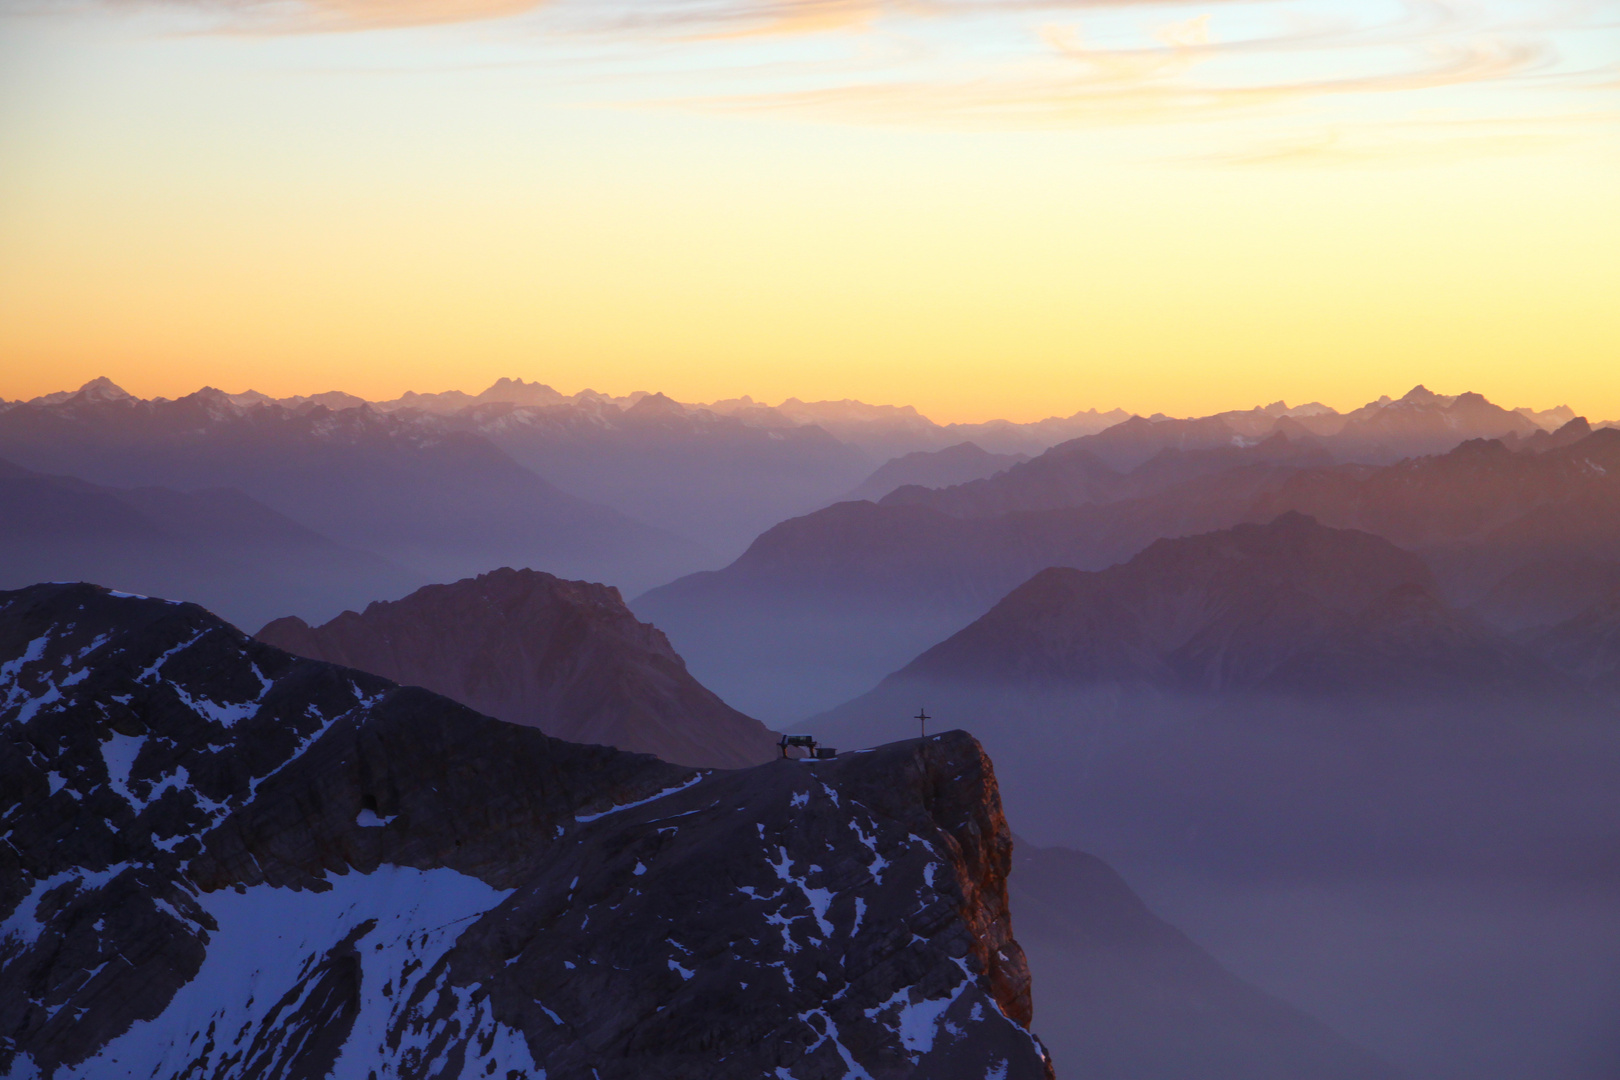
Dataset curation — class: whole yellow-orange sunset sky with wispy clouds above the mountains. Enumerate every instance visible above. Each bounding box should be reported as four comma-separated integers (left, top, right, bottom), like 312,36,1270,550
0,0,1620,421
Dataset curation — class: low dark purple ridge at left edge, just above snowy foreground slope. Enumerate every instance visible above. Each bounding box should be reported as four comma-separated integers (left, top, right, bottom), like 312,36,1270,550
0,461,413,627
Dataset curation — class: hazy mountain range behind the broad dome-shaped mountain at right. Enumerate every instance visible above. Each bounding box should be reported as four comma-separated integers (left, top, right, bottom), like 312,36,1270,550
632,401,1620,724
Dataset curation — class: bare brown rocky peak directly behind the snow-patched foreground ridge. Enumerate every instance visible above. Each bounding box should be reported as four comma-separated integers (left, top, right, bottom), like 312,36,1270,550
258,568,778,769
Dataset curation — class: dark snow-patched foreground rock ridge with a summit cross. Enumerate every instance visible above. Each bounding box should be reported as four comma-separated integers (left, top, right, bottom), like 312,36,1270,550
0,585,1051,1080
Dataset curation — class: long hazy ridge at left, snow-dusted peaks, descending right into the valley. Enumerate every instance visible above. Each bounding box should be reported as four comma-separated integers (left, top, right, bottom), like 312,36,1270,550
0,387,703,599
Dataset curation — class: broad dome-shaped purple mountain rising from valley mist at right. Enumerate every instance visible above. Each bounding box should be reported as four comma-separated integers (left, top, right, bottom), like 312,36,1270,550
893,513,1557,696
